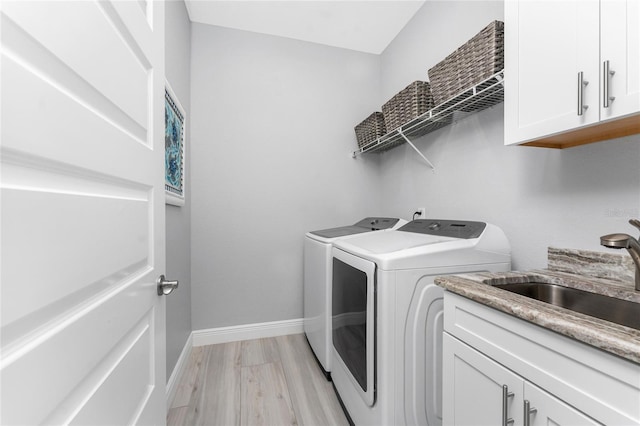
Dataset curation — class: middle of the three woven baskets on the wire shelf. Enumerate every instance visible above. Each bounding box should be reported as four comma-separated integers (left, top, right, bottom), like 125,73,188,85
382,81,433,130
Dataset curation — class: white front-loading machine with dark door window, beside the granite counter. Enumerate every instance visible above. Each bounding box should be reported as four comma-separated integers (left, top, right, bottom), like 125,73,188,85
331,219,511,426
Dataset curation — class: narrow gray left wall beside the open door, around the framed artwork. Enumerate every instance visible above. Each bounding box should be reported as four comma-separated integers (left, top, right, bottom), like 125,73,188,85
165,0,191,380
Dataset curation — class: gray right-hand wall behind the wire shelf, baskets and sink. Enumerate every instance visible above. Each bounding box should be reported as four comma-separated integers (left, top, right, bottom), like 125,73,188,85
378,1,640,269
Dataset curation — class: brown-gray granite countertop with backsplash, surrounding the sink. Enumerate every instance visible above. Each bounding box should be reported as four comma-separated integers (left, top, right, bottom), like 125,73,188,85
435,248,640,363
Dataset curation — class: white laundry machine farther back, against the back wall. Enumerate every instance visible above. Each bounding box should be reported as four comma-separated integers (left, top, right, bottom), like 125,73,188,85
304,217,407,379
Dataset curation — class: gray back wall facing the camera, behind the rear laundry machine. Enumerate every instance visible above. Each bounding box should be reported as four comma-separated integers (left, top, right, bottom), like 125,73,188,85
191,23,382,329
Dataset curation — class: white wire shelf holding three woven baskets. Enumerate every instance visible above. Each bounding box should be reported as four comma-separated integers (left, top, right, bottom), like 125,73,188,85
353,71,504,157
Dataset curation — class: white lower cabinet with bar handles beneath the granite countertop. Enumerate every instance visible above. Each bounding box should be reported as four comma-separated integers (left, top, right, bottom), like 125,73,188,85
442,291,640,426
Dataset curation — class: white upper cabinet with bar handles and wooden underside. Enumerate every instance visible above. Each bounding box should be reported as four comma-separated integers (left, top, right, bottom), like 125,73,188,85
505,0,640,147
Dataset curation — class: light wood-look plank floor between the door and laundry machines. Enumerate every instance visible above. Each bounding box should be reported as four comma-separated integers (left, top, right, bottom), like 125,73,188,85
167,334,348,426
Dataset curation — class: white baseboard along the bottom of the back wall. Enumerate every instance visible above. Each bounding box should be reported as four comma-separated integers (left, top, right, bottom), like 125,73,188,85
192,318,304,346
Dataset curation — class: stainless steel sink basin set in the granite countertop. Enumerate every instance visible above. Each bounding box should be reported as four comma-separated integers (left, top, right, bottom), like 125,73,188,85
494,282,640,330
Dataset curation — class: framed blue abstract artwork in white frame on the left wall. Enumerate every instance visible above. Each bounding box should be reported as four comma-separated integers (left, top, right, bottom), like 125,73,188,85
164,91,184,201
